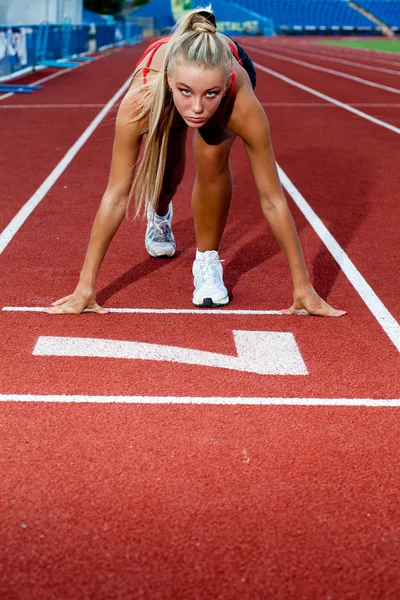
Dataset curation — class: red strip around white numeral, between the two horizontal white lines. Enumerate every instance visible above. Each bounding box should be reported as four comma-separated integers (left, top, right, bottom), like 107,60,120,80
0,302,400,399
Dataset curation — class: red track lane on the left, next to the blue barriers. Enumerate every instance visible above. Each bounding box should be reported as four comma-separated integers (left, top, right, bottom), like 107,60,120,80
0,44,143,230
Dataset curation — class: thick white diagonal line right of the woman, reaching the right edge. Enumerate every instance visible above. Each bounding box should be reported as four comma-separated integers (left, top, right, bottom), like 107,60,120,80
277,165,400,352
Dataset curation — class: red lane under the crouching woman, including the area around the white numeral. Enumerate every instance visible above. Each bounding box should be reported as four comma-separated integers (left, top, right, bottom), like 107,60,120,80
0,123,398,397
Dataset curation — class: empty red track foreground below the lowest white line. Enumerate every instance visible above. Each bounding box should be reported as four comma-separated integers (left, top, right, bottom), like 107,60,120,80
0,404,400,600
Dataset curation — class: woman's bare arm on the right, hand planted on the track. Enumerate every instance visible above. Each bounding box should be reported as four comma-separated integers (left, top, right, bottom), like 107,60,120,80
228,87,343,316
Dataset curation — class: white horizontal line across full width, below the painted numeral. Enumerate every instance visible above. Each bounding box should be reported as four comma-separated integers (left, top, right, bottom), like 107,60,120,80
0,394,400,408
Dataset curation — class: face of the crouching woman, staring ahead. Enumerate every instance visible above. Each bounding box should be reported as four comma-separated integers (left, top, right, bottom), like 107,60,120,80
168,62,227,129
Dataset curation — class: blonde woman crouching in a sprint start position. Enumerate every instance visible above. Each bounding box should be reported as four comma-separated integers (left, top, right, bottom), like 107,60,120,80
46,9,345,317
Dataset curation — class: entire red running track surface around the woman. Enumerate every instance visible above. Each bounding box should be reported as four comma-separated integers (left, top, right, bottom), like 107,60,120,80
0,40,400,600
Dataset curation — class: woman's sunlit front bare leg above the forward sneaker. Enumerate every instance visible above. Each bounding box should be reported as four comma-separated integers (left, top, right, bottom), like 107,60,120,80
192,129,236,252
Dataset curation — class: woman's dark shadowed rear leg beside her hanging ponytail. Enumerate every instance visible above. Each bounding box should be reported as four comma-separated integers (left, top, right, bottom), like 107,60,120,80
156,126,188,217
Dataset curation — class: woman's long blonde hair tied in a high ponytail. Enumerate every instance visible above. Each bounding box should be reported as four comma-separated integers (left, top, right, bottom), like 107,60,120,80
131,8,233,216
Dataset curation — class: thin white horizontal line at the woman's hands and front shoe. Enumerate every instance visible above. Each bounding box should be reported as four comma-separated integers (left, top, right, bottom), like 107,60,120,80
1,306,283,315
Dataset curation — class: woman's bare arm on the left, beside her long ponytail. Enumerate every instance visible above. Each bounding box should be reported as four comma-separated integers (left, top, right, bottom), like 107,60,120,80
47,89,143,314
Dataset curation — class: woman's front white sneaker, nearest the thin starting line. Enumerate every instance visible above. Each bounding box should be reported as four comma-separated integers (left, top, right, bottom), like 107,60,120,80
192,250,229,308
